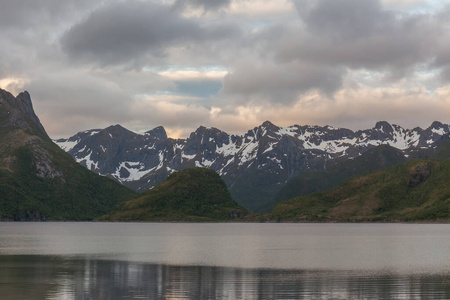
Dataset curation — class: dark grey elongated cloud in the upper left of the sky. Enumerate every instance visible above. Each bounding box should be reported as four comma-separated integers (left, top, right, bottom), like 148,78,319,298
61,1,239,65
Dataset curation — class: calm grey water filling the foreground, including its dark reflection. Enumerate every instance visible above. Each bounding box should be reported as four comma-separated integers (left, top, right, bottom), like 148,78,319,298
0,223,450,299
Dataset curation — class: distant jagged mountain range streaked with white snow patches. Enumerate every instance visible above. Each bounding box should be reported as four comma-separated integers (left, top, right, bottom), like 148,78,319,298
55,121,450,208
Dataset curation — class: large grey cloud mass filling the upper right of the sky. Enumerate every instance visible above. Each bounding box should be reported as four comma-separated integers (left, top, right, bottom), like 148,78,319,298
218,0,450,103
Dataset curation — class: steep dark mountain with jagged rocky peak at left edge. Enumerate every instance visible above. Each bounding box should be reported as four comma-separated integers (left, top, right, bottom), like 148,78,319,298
0,89,136,220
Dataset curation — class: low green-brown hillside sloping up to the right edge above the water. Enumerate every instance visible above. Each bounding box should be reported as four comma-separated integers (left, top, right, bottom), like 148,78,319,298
273,159,450,222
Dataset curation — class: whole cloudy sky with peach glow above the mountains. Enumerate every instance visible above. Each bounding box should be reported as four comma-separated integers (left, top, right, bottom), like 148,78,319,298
0,0,450,138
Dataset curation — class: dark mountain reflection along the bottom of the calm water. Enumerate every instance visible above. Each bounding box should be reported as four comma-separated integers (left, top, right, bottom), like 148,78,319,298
0,256,450,299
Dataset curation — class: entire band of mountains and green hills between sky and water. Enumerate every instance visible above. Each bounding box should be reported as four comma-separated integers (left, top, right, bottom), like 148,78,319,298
0,85,450,222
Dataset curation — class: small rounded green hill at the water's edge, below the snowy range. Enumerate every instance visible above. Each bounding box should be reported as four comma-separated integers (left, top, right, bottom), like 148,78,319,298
100,168,247,221
